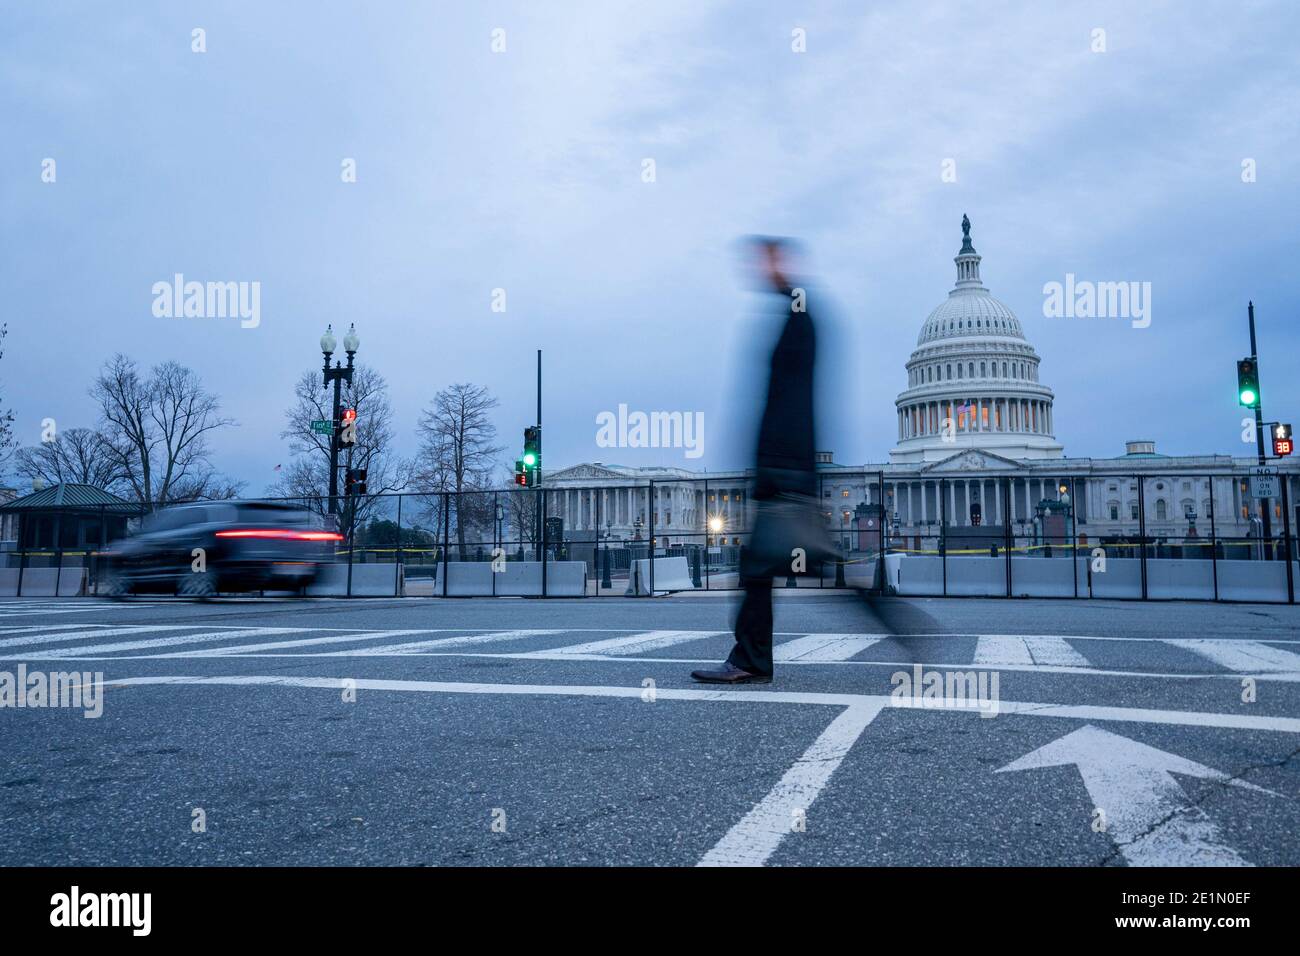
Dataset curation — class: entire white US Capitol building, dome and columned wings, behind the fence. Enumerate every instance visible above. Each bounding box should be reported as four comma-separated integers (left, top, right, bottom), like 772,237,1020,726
545,216,1300,549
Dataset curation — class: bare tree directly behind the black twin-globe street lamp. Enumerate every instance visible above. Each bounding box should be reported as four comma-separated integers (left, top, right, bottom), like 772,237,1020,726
269,365,410,527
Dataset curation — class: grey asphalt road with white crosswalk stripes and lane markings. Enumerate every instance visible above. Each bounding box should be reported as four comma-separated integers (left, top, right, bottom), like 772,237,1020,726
0,594,1300,866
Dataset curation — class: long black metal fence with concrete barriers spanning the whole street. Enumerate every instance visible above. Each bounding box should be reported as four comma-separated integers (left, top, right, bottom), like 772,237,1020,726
0,470,1300,604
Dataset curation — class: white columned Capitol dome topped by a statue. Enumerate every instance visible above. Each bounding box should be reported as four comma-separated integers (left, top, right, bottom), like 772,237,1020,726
889,216,1063,462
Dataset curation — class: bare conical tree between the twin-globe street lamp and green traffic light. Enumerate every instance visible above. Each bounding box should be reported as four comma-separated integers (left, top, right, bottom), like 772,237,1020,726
415,382,502,559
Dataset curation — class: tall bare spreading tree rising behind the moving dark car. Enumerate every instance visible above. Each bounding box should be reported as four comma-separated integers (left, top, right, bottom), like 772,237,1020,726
90,352,239,509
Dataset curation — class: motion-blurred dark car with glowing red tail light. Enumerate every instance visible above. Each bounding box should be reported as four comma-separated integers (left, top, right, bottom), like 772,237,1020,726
101,501,343,597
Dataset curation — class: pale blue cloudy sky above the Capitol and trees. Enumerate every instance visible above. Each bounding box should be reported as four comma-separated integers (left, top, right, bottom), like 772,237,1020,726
0,0,1300,493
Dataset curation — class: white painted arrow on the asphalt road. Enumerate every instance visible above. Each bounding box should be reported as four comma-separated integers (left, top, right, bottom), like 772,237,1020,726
995,724,1277,866
